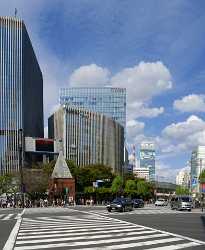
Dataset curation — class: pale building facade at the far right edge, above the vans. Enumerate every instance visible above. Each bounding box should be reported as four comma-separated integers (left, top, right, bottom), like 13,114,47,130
190,146,205,193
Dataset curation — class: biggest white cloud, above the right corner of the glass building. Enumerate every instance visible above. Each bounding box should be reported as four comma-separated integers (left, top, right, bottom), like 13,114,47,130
111,61,172,103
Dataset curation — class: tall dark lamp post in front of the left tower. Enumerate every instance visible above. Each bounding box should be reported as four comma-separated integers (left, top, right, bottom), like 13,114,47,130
18,129,24,208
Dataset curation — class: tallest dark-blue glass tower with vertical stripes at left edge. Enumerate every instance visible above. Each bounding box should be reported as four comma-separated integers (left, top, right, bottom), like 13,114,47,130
0,17,44,173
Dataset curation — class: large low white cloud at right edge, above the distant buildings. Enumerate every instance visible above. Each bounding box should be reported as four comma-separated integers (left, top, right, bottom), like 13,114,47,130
159,115,205,154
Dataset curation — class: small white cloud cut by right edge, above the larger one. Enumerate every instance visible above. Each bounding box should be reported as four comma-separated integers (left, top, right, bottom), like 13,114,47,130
173,94,205,112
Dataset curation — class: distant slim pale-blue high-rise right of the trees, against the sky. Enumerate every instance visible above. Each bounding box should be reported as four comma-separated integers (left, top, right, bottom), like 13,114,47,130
140,142,155,181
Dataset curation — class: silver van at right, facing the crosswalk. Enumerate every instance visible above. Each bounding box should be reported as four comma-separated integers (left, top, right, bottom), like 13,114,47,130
170,196,192,212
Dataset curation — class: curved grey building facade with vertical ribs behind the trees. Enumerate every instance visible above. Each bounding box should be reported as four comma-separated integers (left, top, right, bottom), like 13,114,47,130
48,105,124,174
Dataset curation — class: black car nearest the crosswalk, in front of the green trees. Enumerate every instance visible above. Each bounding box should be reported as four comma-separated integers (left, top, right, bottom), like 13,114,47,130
107,198,133,212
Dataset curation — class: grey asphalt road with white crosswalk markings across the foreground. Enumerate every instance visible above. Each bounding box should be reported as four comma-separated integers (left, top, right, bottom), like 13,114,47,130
0,207,205,250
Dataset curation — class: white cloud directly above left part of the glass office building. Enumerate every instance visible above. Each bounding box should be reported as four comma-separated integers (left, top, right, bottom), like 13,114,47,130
69,64,110,87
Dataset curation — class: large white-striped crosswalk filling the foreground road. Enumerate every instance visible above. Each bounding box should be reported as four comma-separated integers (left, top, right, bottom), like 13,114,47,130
14,213,205,250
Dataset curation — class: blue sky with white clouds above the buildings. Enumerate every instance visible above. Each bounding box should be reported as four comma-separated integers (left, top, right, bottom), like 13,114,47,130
0,0,205,181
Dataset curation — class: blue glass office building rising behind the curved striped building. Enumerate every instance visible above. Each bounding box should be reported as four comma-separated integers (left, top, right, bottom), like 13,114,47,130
60,87,126,128
